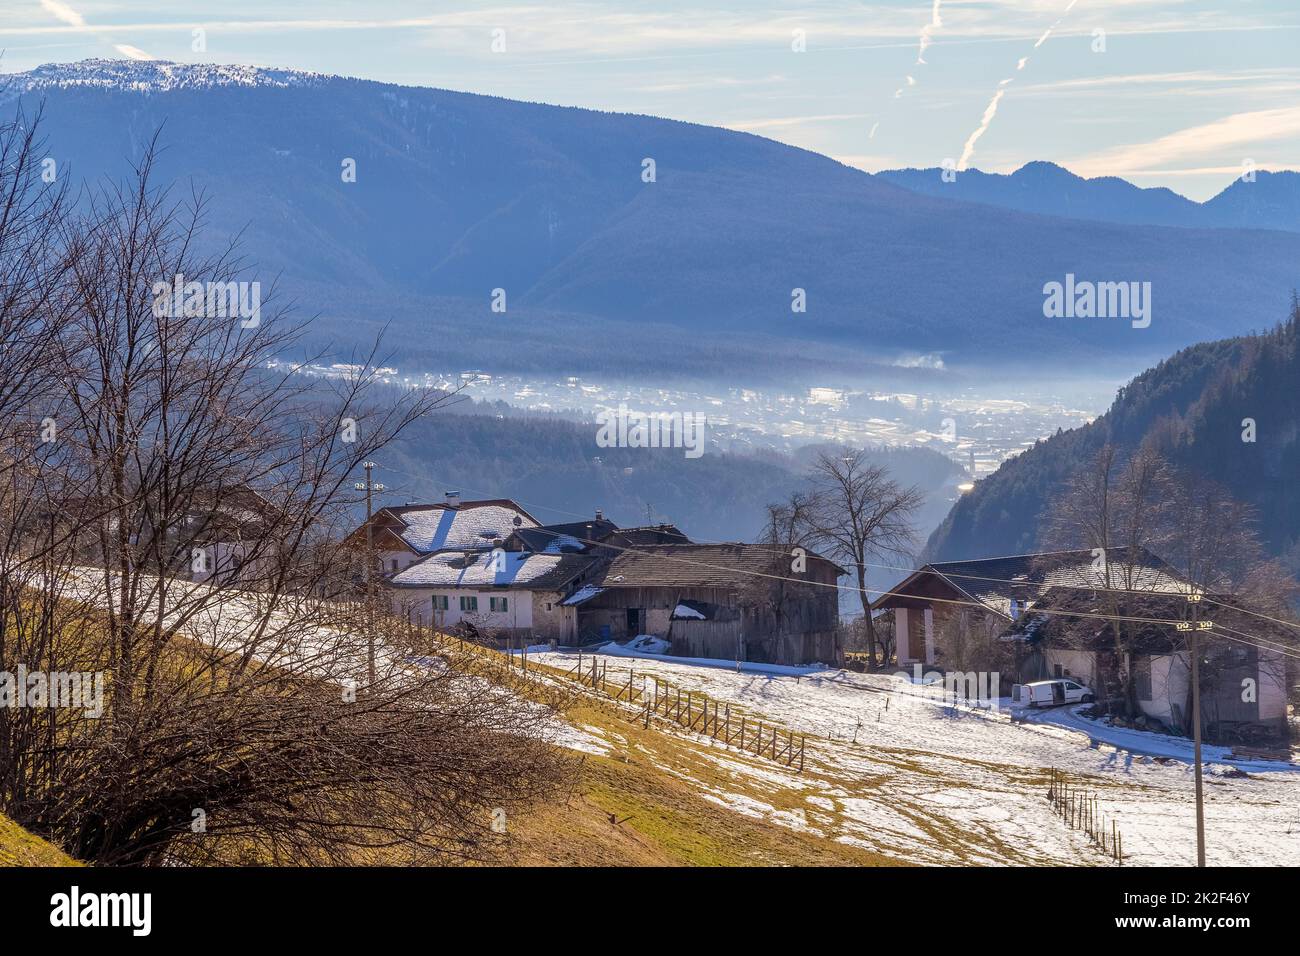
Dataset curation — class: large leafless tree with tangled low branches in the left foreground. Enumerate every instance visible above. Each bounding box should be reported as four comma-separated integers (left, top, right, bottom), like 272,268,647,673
0,132,572,865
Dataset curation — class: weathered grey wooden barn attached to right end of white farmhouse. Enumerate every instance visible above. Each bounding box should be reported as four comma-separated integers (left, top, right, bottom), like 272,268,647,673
566,544,844,665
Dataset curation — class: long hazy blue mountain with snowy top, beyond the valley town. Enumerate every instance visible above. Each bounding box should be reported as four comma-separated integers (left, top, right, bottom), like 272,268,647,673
10,60,1300,375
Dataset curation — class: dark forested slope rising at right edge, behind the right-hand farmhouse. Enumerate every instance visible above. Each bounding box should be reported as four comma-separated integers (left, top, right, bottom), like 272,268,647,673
926,306,1300,570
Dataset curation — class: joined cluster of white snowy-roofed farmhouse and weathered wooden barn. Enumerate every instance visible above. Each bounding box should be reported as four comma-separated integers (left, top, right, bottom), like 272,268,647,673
350,499,842,665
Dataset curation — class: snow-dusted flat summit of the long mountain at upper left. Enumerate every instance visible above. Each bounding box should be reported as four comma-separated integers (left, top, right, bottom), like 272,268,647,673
8,57,329,94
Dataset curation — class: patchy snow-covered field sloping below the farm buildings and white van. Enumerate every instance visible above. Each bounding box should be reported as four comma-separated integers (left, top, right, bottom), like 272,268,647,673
530,653,1300,866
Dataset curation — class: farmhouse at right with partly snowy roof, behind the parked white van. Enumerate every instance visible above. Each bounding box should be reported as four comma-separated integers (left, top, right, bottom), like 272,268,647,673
872,549,1291,741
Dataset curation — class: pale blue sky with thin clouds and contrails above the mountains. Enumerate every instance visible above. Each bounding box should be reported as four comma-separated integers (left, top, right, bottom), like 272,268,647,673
0,0,1300,199
